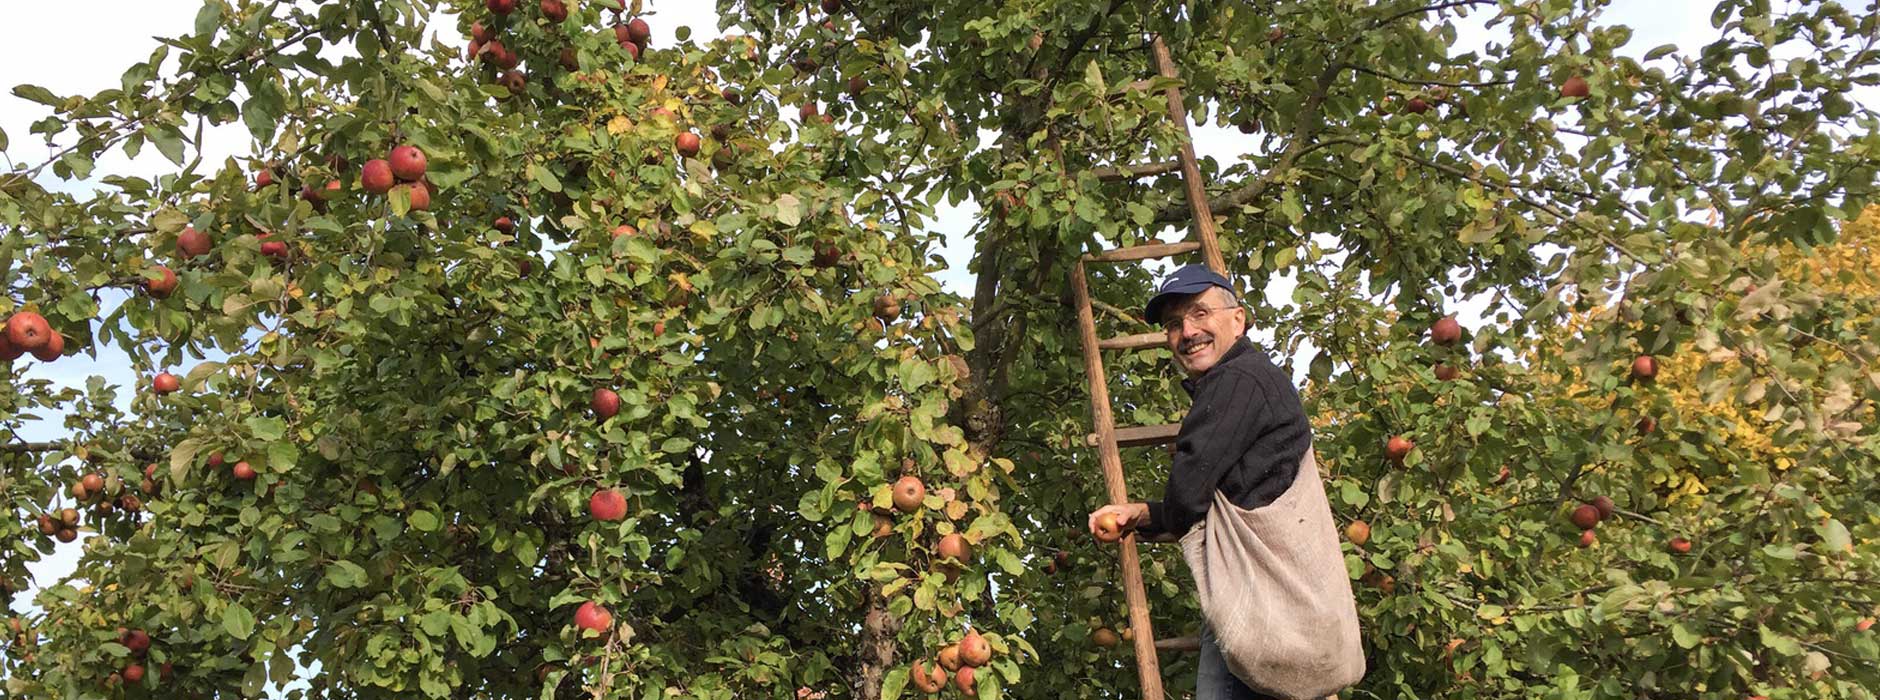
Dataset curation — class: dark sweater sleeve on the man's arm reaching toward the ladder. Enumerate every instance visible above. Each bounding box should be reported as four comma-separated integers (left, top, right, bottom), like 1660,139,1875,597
1137,371,1271,536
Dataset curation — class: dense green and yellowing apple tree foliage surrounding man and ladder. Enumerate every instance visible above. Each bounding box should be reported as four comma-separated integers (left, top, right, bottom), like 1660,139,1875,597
0,0,1880,698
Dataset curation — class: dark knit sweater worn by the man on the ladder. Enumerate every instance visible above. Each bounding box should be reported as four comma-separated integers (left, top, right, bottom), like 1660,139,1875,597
1137,337,1312,536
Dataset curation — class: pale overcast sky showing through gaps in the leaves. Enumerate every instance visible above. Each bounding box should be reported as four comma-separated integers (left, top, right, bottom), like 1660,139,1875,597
0,0,1716,628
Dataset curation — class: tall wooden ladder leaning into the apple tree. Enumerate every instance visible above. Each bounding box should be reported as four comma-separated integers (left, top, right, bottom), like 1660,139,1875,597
1070,36,1228,700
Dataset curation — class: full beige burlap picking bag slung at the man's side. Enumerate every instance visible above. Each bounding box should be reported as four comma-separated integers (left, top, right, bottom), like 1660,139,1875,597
1181,448,1365,698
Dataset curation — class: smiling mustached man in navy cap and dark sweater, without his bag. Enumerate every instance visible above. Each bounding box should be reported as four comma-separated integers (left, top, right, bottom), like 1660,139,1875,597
1089,265,1312,700
